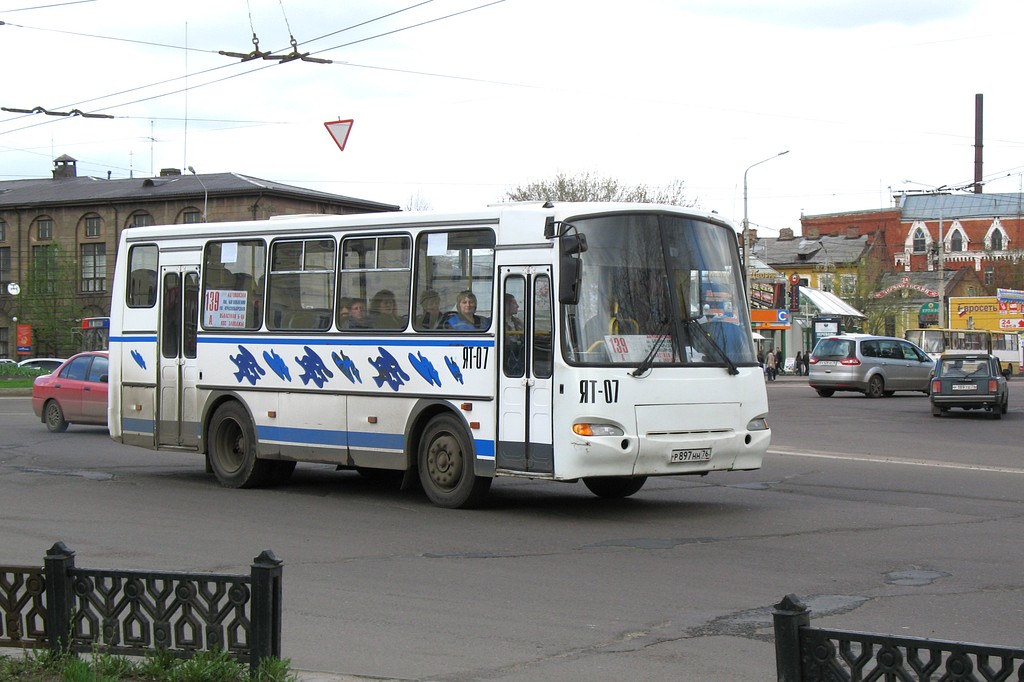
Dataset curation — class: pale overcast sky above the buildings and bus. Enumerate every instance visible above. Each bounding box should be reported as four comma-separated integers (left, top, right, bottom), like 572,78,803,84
0,0,1024,236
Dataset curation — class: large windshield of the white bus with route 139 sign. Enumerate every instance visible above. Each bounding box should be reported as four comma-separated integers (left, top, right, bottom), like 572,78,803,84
564,213,756,371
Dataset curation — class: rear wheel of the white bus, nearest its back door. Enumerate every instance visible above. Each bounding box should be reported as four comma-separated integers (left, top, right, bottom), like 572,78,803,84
210,402,274,487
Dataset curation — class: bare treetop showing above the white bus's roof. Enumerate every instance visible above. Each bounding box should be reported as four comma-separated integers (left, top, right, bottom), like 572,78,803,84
505,172,696,206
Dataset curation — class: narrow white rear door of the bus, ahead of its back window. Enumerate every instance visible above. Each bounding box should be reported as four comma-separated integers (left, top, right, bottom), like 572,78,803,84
157,265,199,447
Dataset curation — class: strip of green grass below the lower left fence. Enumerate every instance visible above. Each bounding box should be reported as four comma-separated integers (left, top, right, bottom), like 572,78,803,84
0,650,298,682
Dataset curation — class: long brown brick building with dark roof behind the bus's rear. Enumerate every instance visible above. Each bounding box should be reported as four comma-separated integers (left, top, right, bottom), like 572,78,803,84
0,156,399,358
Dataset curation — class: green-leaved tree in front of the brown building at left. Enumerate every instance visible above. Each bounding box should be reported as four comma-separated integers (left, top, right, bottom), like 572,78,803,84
18,244,83,357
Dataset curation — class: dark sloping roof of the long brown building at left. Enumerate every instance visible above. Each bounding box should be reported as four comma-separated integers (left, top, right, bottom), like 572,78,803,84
0,168,399,211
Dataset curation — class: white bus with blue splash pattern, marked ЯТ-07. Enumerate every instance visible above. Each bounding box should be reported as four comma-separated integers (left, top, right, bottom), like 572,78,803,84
109,204,771,507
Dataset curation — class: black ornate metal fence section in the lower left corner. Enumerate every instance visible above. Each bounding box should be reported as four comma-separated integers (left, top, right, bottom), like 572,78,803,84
0,543,283,670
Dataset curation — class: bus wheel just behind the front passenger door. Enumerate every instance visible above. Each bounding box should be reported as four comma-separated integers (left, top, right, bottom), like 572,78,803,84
417,415,490,509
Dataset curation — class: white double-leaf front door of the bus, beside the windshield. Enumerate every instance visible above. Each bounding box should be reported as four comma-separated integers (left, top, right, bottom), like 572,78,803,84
496,266,555,473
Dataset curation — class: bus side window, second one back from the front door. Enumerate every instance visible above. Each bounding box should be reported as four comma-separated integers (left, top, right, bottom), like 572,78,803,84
338,235,413,331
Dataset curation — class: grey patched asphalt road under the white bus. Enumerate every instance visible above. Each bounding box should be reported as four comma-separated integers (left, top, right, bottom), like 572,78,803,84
0,379,1024,682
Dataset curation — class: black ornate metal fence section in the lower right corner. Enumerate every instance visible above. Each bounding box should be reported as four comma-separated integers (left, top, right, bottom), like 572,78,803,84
773,595,1024,682
